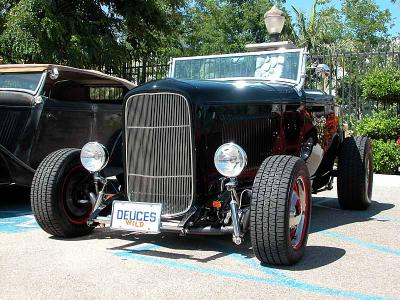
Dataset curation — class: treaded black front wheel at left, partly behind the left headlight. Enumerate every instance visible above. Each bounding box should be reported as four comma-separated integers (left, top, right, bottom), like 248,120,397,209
31,149,93,238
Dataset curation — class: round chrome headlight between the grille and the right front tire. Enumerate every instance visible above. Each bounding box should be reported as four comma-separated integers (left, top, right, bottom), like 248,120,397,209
214,143,247,177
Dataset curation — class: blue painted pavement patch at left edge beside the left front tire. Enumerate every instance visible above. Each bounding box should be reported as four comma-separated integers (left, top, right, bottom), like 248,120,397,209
0,210,39,233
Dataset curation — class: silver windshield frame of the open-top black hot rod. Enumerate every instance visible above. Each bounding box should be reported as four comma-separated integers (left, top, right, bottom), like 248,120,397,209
168,48,306,86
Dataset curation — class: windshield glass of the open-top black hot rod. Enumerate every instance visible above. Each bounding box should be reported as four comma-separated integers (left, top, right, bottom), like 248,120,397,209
170,50,301,82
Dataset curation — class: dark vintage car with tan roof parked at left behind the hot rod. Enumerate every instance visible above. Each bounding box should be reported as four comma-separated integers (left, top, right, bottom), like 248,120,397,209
0,64,135,187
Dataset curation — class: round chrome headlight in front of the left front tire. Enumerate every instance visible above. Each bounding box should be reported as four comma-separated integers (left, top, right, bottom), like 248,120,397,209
81,142,108,172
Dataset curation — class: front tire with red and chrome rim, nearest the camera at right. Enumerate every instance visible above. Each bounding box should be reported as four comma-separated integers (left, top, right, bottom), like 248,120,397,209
250,155,311,265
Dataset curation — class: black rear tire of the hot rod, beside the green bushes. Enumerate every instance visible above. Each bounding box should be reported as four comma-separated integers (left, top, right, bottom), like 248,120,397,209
337,137,373,210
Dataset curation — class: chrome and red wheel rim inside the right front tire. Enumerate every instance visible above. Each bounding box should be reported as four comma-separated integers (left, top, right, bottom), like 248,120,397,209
289,176,310,250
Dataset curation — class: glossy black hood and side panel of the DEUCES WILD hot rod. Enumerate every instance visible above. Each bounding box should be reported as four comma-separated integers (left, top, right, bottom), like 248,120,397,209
125,79,337,207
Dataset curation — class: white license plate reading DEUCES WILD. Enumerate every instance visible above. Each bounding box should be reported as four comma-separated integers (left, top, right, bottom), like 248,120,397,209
111,201,162,233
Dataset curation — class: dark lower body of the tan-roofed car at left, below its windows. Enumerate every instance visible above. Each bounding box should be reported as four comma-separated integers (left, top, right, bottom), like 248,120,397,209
0,82,125,186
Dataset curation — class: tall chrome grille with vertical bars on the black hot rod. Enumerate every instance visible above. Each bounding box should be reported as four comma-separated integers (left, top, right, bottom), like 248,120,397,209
125,93,194,217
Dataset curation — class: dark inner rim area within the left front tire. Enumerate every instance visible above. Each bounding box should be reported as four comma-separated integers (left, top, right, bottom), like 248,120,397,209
58,166,92,225
